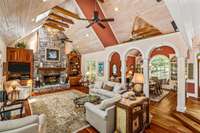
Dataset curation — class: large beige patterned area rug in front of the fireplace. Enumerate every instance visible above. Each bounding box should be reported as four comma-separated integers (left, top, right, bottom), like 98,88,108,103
29,90,88,133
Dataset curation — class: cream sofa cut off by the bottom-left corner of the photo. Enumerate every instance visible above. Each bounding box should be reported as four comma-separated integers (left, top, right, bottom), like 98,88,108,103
0,114,46,133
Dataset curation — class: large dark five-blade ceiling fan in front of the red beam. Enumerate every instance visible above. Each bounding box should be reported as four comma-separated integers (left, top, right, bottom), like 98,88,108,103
80,1,114,29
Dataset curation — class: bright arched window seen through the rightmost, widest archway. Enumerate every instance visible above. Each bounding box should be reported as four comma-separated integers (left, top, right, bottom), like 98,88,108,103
150,55,170,79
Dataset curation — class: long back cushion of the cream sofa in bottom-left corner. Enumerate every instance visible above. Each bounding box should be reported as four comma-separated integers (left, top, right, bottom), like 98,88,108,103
0,115,39,132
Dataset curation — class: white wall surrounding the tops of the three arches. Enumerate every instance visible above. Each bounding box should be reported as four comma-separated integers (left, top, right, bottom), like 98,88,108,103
81,32,188,79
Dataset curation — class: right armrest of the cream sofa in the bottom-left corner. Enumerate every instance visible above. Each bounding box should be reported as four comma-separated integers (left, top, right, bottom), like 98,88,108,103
39,114,47,133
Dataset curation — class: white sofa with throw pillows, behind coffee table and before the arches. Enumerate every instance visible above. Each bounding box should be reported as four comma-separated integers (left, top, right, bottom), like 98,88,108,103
89,80,127,99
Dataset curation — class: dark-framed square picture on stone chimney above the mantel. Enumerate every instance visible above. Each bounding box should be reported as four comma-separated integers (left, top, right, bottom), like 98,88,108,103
45,48,60,62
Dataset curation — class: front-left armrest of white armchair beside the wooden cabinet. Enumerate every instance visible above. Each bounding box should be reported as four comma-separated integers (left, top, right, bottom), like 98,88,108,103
84,102,107,119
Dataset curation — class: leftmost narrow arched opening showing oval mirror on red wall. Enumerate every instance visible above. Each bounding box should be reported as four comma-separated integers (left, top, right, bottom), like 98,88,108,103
109,52,121,82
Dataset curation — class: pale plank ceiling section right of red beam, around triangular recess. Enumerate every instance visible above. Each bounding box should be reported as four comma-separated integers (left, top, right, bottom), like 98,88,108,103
101,0,174,43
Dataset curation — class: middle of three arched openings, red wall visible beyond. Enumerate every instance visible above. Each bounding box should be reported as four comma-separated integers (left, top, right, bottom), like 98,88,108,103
125,49,143,89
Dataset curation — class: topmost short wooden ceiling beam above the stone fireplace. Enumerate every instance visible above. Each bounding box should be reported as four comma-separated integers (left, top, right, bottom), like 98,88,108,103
53,6,80,19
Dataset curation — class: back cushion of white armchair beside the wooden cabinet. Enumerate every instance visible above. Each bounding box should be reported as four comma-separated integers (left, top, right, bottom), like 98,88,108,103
98,95,121,110
